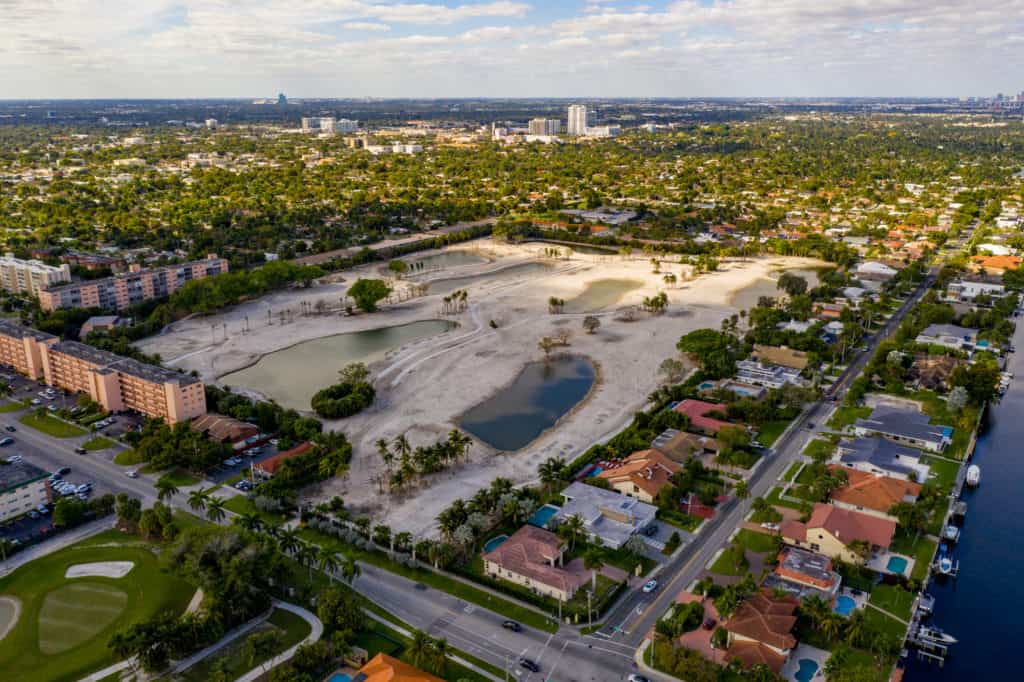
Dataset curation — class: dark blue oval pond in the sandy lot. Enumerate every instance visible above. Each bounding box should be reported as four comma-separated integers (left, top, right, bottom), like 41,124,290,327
459,355,596,451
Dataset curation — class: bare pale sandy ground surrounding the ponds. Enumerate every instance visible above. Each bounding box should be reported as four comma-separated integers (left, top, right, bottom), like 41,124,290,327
139,240,821,534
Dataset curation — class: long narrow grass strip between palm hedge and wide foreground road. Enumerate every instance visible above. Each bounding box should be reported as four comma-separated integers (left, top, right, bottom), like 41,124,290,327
299,528,558,632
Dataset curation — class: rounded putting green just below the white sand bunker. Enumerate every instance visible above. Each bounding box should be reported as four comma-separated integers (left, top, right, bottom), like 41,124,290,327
39,581,128,654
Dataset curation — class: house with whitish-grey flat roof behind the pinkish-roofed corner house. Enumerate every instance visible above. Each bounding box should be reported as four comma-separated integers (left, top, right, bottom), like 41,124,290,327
553,481,657,549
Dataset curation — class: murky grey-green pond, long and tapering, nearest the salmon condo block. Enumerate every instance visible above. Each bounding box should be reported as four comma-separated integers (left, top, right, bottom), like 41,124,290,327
219,319,458,411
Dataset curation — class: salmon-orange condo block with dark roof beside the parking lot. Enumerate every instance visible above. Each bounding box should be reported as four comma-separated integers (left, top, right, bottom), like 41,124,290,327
0,321,206,424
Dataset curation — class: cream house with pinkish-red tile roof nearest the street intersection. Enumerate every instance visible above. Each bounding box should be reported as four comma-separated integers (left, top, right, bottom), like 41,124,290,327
483,525,586,601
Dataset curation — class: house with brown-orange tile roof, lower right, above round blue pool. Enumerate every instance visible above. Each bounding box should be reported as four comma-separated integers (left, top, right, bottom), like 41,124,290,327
722,590,800,674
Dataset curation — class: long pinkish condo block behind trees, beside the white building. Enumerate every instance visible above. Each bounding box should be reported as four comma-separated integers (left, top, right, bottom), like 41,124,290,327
39,253,227,310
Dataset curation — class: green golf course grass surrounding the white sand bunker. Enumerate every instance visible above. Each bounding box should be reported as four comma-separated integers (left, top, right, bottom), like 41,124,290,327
0,530,195,681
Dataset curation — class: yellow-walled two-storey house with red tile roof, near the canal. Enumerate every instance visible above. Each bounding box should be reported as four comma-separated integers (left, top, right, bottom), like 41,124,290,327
779,504,896,563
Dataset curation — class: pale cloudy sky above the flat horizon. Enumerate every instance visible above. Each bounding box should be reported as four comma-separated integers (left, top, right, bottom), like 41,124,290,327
0,0,1024,99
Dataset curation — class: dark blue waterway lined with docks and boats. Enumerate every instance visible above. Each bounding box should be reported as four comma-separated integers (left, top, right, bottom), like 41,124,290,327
905,324,1024,682
